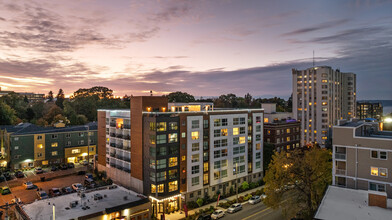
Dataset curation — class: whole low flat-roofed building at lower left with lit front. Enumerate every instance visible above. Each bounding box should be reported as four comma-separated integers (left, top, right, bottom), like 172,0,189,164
15,185,151,220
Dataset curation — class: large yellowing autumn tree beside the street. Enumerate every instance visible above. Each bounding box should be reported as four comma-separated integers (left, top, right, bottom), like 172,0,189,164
264,147,332,219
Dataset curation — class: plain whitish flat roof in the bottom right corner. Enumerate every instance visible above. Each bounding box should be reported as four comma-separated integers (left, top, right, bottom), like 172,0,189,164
314,186,392,220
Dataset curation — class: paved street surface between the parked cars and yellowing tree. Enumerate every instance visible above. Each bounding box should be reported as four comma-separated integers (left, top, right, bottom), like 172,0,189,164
217,202,284,220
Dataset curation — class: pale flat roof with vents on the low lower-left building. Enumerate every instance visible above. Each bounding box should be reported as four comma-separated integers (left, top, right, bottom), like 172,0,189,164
22,185,148,220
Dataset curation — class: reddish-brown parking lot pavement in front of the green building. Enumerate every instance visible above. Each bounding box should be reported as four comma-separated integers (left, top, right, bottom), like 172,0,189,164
0,165,87,205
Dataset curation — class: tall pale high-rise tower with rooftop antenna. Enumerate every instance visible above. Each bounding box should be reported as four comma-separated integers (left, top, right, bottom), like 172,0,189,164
292,66,356,147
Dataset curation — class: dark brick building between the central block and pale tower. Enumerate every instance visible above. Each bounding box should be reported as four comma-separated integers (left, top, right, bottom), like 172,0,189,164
261,103,302,152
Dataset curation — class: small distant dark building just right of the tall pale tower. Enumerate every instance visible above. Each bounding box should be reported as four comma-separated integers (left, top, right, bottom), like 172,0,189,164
357,101,383,121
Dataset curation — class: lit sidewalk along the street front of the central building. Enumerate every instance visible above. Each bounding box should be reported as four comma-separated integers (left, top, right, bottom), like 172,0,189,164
165,185,264,220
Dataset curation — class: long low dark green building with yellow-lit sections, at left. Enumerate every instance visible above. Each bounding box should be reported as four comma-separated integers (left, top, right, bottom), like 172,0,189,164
0,122,97,170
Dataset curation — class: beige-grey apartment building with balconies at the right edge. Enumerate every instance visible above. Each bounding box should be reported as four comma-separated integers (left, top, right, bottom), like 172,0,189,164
332,120,392,199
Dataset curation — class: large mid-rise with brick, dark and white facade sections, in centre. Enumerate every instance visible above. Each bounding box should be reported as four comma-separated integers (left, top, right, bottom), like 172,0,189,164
98,96,263,217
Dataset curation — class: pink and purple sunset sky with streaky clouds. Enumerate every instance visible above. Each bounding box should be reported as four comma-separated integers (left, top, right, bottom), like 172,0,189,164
0,0,392,99
